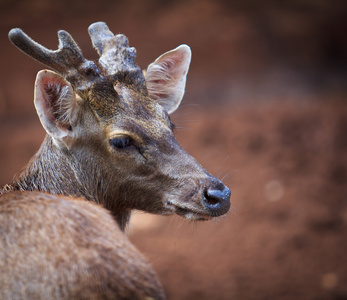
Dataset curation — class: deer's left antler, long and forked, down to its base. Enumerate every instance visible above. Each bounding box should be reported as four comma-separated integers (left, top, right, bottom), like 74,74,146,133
8,28,99,87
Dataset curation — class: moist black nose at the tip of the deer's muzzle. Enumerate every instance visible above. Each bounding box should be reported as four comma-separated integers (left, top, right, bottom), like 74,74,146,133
202,185,231,217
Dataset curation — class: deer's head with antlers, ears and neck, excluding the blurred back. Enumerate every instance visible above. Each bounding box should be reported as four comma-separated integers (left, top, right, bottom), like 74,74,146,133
9,22,230,228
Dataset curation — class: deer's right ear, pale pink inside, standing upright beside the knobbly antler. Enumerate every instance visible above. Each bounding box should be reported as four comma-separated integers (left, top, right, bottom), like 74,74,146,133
145,45,192,114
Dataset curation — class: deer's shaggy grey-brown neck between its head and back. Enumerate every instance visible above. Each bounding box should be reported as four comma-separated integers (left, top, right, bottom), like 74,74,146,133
4,136,131,230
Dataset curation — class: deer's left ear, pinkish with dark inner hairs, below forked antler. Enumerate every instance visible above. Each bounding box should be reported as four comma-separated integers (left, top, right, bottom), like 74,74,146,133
34,70,77,146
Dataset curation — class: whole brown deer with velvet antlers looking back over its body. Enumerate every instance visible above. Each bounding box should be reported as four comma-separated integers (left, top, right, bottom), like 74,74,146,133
0,22,231,299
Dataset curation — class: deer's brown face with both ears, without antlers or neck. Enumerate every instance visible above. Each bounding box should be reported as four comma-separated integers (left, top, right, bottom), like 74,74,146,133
9,22,230,220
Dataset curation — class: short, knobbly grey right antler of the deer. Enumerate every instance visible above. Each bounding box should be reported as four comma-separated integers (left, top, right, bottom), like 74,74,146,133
88,22,138,75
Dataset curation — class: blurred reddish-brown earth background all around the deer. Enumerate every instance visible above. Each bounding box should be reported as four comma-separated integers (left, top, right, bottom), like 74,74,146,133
0,0,347,300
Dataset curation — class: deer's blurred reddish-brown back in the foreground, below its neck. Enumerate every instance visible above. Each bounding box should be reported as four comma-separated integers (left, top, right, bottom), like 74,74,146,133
0,192,164,299
